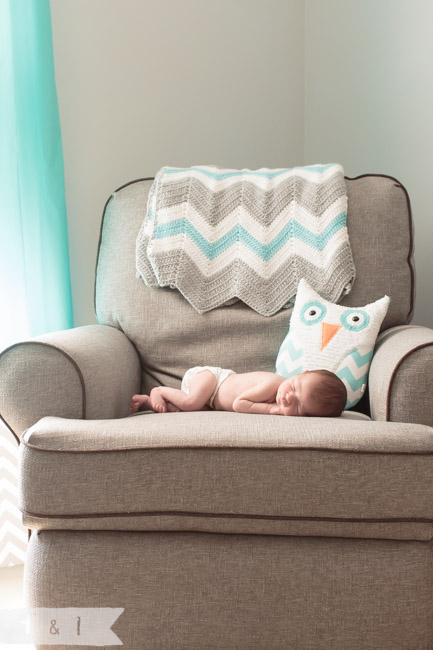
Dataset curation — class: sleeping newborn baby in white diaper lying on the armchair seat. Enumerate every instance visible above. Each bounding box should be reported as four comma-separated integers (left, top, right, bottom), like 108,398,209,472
130,366,347,417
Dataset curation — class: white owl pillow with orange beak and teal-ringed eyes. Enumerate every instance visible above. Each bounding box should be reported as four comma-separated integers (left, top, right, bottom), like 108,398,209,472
276,280,389,409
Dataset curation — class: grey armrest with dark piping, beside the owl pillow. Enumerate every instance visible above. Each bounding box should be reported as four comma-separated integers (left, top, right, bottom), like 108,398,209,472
369,325,433,426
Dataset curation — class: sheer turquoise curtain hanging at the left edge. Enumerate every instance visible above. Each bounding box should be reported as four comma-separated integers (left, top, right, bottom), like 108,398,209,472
0,0,73,349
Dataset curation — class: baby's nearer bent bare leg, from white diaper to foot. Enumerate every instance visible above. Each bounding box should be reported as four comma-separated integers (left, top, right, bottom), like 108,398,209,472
150,370,217,413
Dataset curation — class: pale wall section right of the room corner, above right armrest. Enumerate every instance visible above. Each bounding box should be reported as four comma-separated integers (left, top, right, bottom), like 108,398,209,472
305,0,433,327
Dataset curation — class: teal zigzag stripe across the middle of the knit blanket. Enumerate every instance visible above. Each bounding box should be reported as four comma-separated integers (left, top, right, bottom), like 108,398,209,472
153,212,347,262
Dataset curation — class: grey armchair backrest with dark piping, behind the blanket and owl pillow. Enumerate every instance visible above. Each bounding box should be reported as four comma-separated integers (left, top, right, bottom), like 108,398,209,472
95,175,414,391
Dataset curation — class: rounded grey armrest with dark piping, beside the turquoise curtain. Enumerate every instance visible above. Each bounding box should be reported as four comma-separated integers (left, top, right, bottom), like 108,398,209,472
0,325,141,437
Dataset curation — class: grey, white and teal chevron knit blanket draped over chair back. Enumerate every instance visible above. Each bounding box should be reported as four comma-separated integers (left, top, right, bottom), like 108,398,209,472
136,164,355,316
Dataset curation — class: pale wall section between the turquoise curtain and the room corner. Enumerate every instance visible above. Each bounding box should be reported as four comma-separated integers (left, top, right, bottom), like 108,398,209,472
51,0,304,325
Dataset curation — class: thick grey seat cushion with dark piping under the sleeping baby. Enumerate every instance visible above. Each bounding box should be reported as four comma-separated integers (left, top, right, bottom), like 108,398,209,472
20,411,433,539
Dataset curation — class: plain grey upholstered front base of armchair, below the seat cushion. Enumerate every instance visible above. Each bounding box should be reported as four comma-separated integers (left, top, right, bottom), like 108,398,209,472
27,530,433,650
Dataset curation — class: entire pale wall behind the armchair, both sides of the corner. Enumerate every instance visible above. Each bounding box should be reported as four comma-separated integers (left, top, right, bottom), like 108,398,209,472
51,0,433,327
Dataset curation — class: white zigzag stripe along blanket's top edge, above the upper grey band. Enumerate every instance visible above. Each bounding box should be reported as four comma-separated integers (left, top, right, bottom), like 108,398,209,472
161,165,342,190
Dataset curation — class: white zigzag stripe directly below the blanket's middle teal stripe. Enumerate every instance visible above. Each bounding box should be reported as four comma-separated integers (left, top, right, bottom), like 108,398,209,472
149,228,352,279
